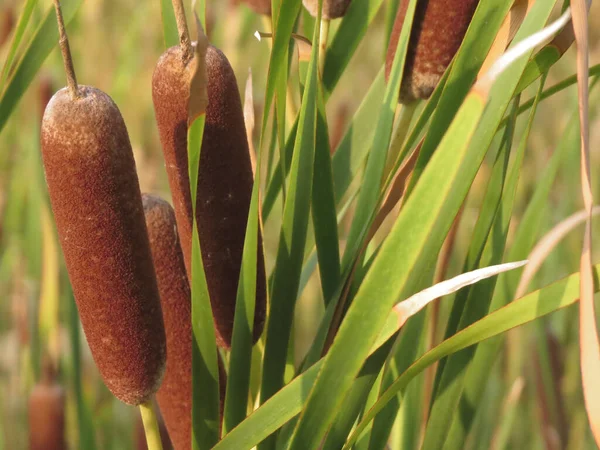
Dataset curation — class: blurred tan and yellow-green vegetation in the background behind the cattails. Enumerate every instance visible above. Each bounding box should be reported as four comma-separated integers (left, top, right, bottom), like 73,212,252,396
0,0,600,450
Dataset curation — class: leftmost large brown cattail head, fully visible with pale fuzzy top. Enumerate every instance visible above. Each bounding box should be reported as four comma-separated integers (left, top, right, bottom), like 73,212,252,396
41,86,166,405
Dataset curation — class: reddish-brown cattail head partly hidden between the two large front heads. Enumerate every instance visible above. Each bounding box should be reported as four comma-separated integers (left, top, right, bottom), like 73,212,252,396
142,194,227,449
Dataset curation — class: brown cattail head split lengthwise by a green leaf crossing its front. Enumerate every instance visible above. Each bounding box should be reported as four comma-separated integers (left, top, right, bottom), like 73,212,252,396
152,46,266,348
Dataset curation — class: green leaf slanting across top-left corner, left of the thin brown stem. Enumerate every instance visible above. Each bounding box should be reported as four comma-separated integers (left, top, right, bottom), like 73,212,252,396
0,0,83,132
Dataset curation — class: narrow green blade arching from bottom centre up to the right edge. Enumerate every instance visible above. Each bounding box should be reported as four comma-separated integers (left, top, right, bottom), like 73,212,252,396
344,265,600,450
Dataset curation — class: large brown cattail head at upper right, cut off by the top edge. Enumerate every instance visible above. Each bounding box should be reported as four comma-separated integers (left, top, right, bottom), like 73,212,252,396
385,0,479,103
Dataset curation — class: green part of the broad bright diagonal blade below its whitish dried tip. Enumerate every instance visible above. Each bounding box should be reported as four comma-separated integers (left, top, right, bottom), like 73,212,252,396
292,75,484,449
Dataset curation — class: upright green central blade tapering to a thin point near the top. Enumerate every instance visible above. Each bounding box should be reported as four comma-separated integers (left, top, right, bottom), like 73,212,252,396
261,0,319,414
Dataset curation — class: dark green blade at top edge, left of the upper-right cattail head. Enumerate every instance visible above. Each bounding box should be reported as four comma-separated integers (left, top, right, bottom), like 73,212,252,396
323,0,383,98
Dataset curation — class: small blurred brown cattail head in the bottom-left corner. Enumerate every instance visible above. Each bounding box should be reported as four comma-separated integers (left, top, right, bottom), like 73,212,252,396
28,380,67,450
